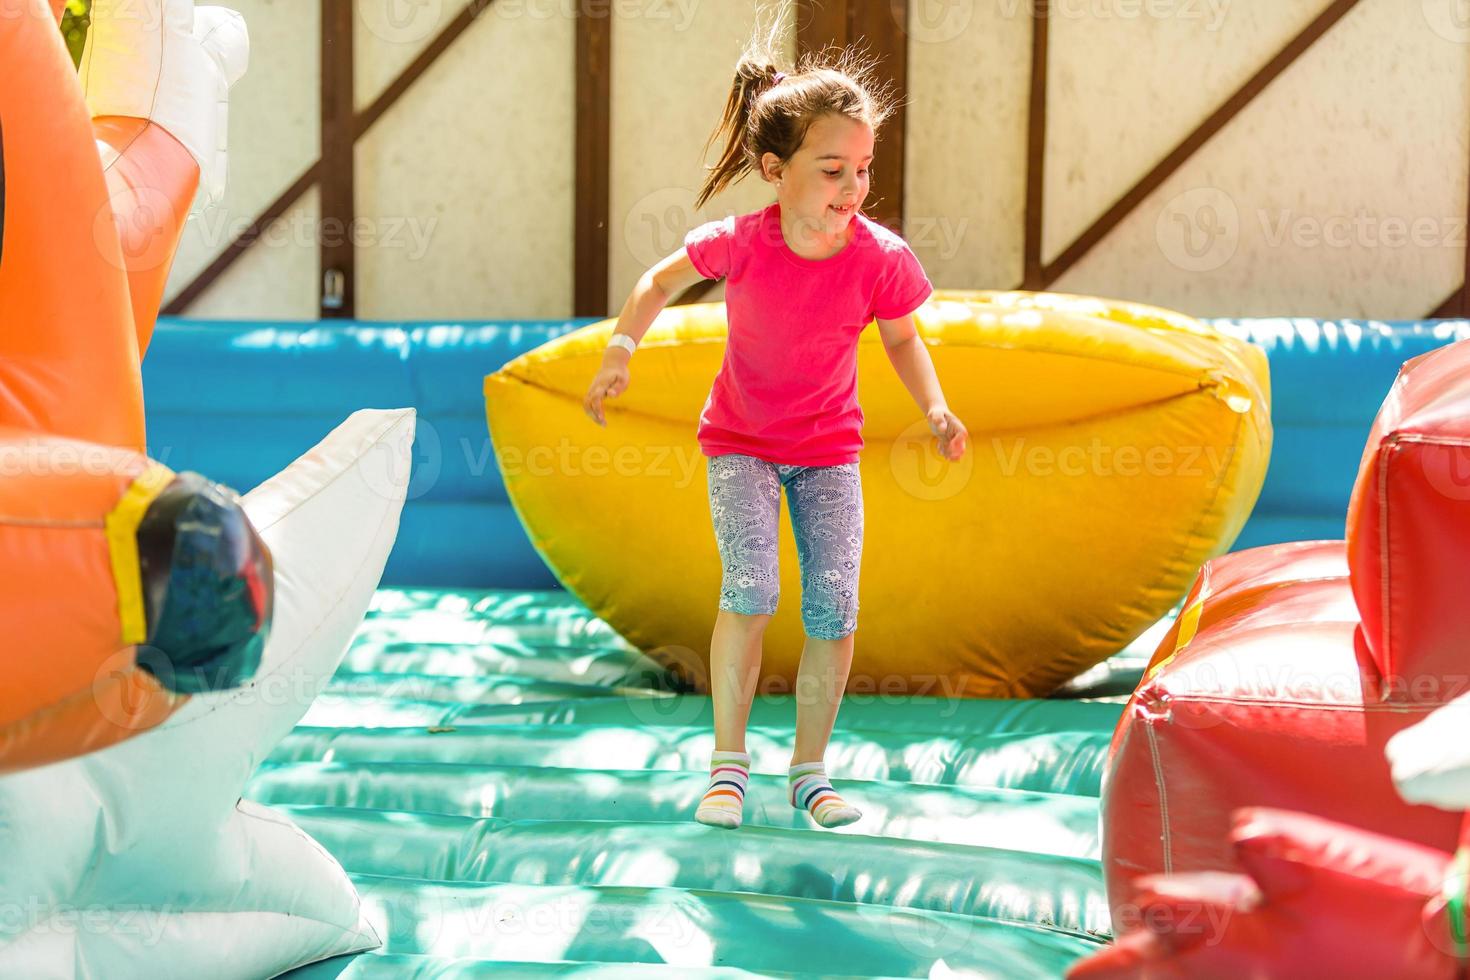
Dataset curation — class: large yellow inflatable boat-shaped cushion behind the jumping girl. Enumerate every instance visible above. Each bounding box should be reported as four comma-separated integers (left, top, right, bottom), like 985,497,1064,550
485,291,1272,698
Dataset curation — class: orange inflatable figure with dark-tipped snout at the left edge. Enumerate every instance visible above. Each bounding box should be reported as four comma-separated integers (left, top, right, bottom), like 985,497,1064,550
0,0,270,773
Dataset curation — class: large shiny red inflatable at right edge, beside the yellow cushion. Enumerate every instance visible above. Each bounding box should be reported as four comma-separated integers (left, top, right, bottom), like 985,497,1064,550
1103,334,1470,934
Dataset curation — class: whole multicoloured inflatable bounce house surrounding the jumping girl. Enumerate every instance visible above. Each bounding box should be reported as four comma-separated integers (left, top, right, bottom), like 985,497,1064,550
0,0,1470,980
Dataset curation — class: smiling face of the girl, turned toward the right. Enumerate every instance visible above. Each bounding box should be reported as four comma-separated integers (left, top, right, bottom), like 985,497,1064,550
761,115,873,238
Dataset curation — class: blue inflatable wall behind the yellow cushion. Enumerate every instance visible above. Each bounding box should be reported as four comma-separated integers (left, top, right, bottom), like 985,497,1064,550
143,317,1470,589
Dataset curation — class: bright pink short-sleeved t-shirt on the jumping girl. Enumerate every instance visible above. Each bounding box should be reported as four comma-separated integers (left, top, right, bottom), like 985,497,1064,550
684,201,933,466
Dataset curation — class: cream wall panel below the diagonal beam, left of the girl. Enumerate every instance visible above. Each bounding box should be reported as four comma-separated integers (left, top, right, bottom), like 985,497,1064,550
349,0,576,319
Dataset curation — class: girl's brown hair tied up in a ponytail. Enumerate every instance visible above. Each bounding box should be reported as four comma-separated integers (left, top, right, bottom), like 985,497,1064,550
694,16,897,210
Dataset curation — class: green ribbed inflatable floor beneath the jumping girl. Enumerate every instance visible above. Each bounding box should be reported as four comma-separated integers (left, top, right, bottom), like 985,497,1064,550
264,591,1138,980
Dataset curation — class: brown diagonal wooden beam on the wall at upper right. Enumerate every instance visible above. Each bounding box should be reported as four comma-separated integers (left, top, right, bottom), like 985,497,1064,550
1041,0,1360,288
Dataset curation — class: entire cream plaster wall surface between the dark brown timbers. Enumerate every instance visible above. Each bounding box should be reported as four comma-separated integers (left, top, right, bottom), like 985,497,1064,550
169,0,1470,319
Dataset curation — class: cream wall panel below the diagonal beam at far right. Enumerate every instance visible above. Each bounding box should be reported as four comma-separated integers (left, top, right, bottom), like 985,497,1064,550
1055,0,1470,319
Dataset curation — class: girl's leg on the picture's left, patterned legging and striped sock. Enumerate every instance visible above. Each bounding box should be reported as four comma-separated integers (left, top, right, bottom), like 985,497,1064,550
694,454,781,827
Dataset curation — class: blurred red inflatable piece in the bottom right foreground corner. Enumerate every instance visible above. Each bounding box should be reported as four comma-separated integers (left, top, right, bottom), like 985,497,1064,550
1067,810,1464,980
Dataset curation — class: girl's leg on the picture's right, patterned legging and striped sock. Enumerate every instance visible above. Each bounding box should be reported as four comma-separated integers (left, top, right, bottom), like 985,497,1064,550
786,463,863,827
